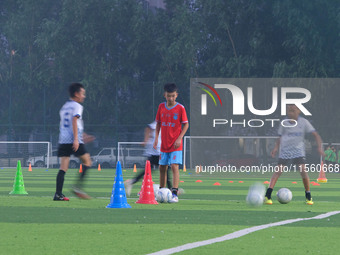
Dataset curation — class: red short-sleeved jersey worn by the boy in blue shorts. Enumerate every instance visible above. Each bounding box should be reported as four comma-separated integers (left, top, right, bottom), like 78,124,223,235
156,102,188,152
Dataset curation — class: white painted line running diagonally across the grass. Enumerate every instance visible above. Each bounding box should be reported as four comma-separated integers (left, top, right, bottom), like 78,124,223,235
149,211,340,255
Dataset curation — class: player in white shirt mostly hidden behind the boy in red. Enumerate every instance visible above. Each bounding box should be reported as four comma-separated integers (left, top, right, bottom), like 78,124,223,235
124,121,171,196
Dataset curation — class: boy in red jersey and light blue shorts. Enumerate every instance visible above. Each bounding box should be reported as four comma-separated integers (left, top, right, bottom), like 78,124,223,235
153,83,189,203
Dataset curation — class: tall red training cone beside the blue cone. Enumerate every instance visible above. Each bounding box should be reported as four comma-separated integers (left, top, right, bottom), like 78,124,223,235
136,160,158,205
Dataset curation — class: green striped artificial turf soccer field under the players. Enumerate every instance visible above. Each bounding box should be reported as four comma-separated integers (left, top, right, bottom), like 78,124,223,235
0,168,340,254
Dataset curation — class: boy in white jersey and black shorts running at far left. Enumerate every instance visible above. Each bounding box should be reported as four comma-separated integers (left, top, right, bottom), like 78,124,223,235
53,83,94,201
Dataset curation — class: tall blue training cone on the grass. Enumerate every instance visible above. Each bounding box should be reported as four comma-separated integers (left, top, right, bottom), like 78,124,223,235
106,161,131,208
